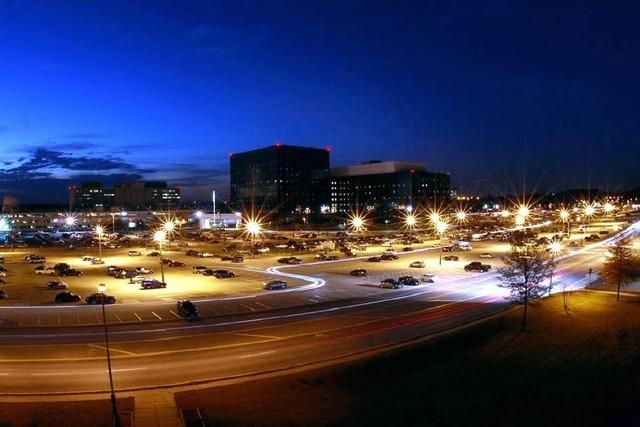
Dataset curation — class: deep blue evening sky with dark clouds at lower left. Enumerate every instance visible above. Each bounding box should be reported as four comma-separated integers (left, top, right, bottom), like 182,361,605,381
0,0,640,202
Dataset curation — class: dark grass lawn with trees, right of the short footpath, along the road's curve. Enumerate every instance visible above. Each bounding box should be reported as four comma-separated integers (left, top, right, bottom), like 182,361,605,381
176,292,640,426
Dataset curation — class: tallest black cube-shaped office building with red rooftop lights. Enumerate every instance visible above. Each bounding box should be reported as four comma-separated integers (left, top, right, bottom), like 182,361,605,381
230,144,329,215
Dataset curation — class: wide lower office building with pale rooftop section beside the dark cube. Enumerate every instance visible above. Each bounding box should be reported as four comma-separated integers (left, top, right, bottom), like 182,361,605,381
320,161,450,213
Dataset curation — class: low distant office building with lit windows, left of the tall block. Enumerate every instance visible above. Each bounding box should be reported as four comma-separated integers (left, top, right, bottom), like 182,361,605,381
69,181,180,211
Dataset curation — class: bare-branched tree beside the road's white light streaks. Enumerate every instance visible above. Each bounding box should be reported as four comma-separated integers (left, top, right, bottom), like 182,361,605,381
498,246,557,331
